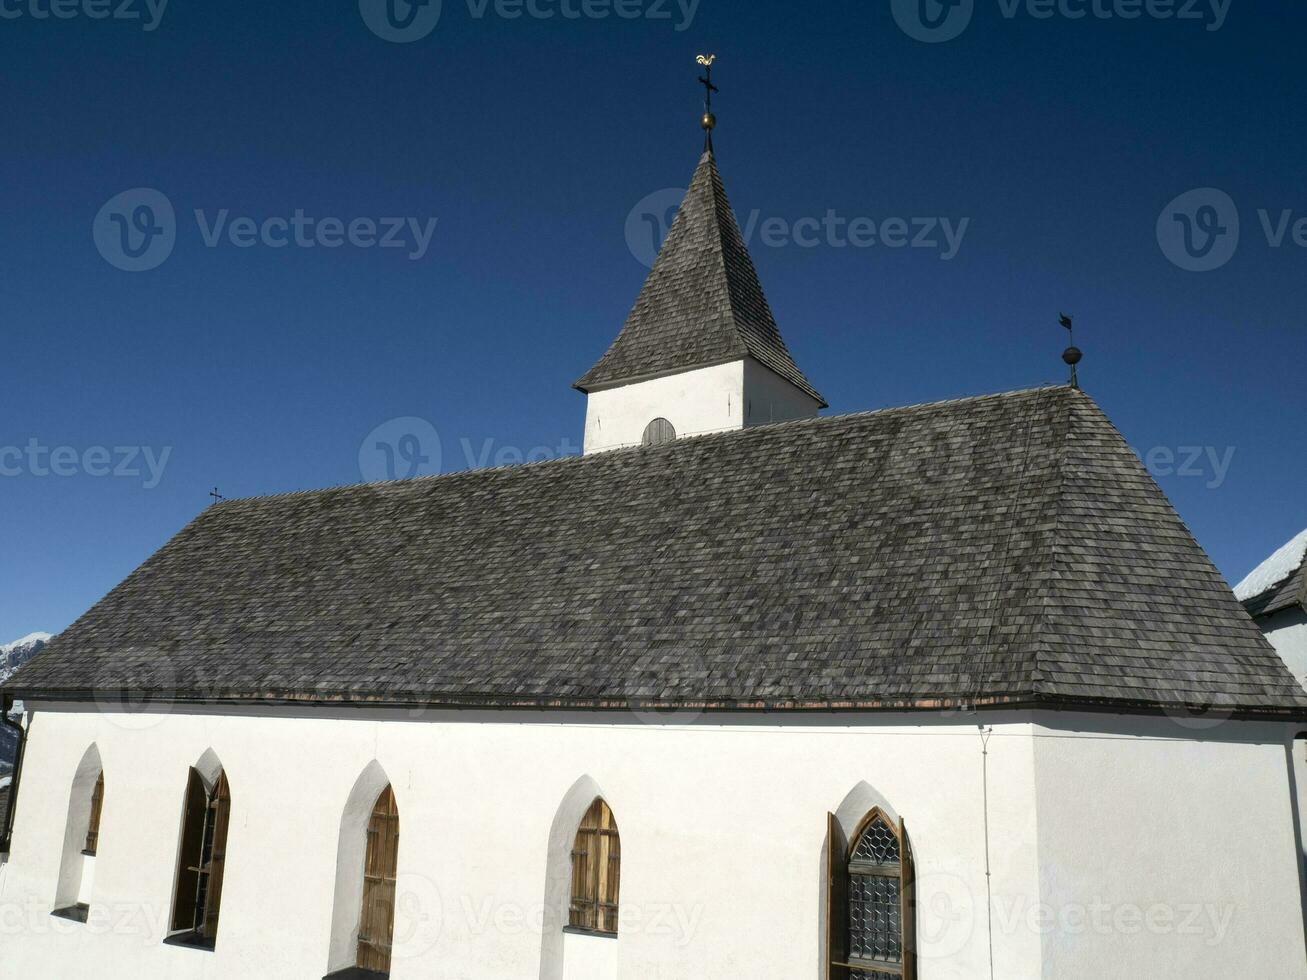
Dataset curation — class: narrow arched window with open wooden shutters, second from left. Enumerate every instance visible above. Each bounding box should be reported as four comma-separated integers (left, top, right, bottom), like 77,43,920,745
169,768,231,950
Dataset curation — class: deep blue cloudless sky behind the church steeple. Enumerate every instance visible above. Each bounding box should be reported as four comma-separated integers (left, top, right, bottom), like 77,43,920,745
0,0,1307,640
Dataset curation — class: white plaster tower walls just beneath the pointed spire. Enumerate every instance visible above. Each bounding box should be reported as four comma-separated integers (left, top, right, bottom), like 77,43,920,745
586,359,817,452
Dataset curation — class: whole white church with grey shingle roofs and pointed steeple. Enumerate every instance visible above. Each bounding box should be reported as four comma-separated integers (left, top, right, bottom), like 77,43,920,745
0,116,1307,980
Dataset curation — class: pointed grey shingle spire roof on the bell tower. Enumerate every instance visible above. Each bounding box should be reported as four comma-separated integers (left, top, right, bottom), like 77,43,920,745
575,152,826,408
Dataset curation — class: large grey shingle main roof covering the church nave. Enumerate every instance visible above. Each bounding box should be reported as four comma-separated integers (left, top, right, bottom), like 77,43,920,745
5,388,1307,713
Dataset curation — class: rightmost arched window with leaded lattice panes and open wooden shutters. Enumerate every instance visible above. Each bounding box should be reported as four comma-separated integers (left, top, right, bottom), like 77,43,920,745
826,809,916,980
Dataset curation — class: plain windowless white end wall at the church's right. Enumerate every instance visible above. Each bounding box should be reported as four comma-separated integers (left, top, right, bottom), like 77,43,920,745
1029,716,1307,980
